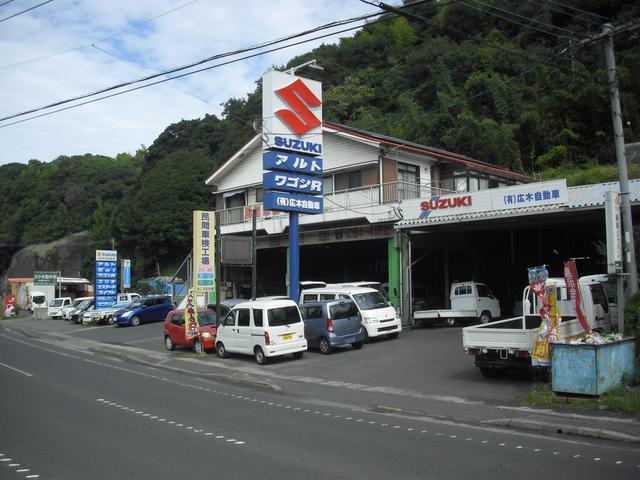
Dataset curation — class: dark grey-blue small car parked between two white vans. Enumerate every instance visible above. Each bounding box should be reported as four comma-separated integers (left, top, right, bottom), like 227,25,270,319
300,300,365,355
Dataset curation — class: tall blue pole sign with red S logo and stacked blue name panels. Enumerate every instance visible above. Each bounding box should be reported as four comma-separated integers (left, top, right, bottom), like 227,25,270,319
262,71,323,303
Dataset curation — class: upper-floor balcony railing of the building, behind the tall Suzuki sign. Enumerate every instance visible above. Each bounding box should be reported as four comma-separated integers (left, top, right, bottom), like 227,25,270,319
218,182,452,226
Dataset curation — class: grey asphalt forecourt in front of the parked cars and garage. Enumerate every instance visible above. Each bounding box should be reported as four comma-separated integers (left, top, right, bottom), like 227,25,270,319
2,319,533,405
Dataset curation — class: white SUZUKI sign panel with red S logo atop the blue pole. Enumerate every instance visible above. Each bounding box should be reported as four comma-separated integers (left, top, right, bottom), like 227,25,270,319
262,70,322,155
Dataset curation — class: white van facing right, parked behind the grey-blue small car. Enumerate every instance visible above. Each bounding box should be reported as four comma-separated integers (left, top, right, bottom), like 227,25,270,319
300,285,402,338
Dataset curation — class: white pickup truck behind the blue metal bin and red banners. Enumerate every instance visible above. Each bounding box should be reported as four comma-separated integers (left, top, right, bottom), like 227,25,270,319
462,277,611,377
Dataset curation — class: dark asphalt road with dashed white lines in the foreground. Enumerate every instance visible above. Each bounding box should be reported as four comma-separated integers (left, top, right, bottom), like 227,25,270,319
0,331,640,480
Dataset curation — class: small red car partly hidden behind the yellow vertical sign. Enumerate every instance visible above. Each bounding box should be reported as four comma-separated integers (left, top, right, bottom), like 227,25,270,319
163,309,218,353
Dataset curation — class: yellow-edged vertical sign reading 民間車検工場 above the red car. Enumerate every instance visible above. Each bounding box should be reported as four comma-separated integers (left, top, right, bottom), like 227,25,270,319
192,210,215,292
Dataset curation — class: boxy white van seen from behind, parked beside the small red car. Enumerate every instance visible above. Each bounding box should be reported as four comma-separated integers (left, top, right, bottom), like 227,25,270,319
216,299,307,365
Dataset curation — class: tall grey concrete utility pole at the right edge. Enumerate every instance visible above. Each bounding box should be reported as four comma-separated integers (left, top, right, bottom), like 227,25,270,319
602,23,638,295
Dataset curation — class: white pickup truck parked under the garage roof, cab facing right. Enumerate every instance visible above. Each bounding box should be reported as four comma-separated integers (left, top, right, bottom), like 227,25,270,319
413,281,500,327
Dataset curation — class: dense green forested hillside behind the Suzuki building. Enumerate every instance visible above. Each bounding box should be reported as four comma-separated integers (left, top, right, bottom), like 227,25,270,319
0,0,640,276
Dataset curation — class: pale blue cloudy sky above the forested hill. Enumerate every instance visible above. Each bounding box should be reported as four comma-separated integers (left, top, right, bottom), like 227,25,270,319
0,0,377,164
